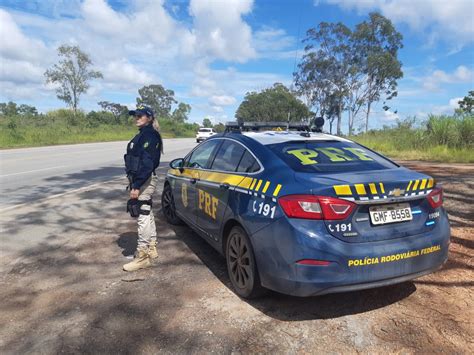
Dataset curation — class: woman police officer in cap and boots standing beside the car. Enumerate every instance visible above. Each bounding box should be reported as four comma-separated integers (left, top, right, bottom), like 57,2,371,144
123,105,163,271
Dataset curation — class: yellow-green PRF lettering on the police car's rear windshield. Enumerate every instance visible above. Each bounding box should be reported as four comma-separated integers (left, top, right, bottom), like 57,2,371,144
286,147,373,165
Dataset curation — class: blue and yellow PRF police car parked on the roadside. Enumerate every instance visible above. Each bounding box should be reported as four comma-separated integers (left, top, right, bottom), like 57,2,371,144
162,123,450,298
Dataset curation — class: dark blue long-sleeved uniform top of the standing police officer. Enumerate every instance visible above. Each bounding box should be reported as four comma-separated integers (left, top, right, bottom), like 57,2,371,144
125,124,163,189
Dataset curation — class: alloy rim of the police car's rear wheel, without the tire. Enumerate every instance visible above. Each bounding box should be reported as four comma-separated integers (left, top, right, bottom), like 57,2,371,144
229,234,252,288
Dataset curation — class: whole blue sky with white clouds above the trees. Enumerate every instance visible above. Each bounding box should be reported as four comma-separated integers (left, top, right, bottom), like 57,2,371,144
0,0,474,132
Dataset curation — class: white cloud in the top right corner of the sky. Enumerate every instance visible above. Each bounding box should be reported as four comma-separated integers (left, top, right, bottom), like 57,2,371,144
326,0,474,47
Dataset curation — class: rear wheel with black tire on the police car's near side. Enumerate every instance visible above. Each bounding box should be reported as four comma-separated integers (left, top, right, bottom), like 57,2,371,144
226,226,265,299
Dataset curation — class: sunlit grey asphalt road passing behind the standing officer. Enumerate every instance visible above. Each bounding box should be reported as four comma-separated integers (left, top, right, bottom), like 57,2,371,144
0,139,196,212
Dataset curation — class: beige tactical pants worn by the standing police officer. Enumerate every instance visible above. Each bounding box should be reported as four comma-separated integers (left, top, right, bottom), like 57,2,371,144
138,175,158,249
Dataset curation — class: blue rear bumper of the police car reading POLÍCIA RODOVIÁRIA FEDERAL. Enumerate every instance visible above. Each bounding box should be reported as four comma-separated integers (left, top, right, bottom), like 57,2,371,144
251,216,450,296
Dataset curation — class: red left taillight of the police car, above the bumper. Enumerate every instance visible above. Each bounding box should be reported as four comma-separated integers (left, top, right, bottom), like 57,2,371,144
278,195,355,220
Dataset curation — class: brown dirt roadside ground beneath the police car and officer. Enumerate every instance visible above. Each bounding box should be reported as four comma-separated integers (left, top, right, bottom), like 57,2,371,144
0,162,474,354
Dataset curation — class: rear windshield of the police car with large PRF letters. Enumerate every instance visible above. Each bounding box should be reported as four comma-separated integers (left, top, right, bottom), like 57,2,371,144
268,141,397,173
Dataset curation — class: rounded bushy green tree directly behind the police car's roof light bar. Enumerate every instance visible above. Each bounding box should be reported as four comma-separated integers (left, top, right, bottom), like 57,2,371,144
235,83,313,122
